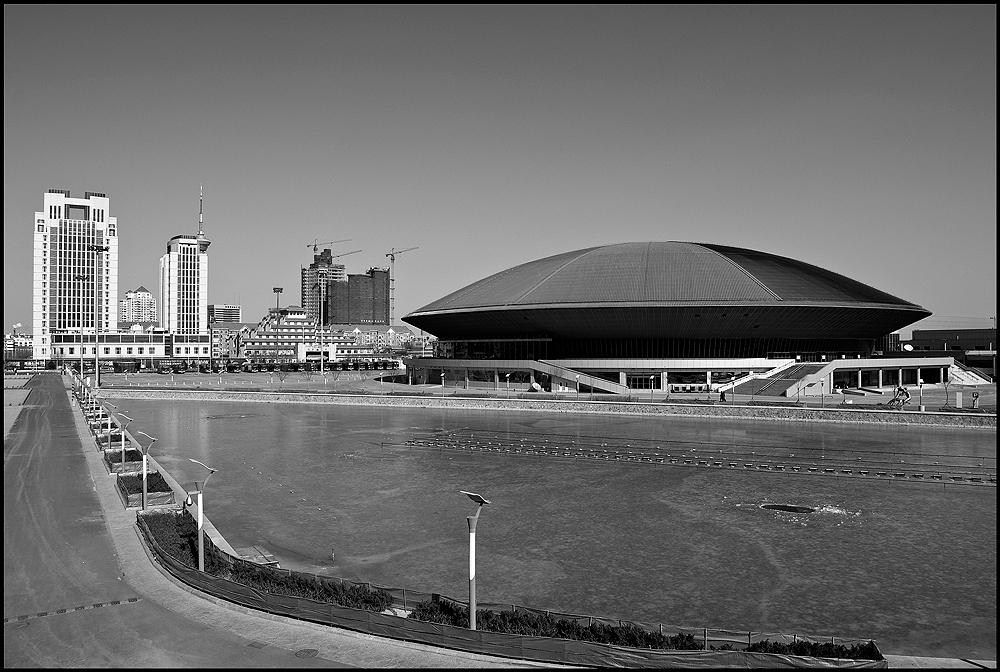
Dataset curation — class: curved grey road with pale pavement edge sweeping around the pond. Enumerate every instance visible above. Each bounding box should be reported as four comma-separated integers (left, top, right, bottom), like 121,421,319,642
4,374,538,668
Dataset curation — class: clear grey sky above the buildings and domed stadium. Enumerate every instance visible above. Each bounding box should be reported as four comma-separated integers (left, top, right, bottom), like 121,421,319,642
4,5,997,337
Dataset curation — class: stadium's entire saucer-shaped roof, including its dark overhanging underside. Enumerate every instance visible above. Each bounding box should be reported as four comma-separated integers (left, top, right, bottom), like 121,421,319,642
403,242,930,339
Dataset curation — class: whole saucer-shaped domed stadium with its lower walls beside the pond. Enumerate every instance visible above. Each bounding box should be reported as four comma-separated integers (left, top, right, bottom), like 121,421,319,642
403,242,944,392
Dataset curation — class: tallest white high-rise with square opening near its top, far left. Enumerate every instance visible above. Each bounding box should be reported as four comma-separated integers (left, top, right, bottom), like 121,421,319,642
32,189,118,359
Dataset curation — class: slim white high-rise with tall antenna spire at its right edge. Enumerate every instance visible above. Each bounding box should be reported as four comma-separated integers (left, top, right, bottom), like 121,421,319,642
159,188,211,334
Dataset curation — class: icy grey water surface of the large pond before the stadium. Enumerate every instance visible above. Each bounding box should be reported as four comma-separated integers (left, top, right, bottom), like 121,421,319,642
113,400,996,660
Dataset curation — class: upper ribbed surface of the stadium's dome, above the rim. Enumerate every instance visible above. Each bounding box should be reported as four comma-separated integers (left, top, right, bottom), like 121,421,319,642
414,242,916,315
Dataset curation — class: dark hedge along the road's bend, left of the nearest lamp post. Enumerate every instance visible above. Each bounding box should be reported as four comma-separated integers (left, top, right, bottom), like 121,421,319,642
140,510,392,612
